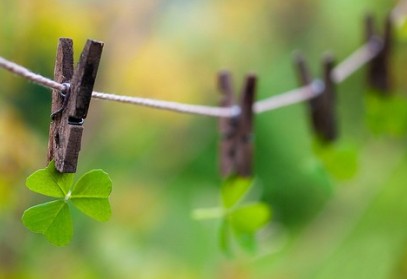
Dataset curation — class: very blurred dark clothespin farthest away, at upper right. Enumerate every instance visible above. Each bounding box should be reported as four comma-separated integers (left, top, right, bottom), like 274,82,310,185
365,14,393,95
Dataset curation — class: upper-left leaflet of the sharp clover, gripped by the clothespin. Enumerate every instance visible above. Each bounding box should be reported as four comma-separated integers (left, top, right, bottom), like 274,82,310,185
26,161,74,198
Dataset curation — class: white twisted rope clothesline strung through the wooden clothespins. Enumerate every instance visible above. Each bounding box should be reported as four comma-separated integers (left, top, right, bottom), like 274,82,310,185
0,38,383,117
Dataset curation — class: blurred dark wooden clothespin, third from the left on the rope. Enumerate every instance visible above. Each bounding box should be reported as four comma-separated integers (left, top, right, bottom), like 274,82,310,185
295,53,338,143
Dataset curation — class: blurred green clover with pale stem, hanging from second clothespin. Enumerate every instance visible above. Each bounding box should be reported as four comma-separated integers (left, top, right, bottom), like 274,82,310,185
193,176,271,255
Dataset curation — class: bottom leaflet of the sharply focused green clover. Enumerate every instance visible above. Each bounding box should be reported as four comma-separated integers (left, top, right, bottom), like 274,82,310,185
22,200,73,246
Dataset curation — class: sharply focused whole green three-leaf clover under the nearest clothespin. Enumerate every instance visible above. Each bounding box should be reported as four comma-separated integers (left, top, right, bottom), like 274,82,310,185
22,162,112,246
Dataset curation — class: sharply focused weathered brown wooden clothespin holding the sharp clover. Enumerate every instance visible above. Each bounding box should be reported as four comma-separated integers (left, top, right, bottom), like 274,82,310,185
48,38,103,173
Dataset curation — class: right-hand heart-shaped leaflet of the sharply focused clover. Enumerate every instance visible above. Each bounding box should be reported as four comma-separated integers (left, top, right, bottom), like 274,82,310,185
71,170,112,222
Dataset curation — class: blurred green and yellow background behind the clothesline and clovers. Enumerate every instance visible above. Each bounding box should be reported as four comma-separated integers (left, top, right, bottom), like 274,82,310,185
0,0,407,279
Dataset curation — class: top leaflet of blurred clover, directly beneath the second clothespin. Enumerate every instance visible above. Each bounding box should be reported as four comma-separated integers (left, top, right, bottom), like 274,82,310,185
221,176,253,208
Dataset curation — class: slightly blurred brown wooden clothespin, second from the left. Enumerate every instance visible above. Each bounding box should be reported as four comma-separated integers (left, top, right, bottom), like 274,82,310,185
218,72,256,177
